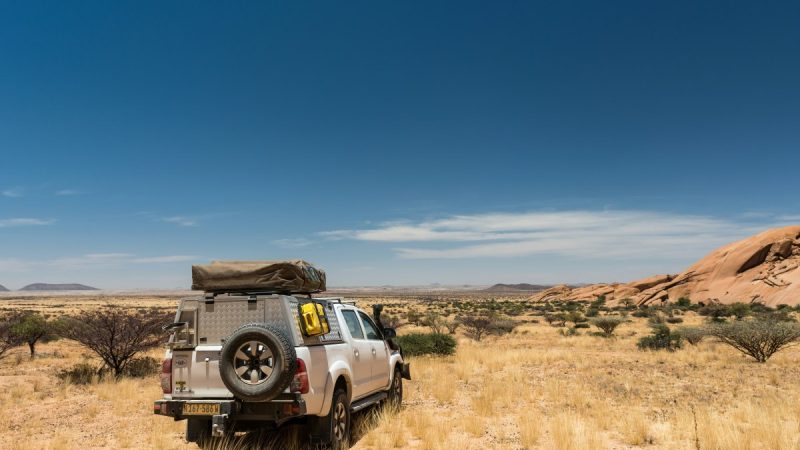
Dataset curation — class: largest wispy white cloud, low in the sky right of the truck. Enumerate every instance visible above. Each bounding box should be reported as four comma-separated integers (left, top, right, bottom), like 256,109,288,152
320,211,762,259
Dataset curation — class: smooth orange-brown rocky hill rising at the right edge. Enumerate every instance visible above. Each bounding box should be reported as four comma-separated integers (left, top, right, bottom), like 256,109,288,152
532,226,800,306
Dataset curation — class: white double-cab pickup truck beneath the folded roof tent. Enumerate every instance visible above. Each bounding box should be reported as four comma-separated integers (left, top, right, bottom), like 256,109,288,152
154,293,410,449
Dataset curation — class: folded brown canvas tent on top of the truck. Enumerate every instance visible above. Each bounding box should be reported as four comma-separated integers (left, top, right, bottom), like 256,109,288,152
192,260,325,294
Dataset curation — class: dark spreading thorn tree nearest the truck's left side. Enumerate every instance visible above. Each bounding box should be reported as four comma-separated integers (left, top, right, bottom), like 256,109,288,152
62,306,170,378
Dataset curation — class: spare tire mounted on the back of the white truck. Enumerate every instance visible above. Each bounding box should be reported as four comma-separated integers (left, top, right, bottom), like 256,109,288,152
219,323,297,402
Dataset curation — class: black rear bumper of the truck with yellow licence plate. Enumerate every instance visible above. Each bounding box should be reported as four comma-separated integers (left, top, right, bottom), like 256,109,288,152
153,394,306,423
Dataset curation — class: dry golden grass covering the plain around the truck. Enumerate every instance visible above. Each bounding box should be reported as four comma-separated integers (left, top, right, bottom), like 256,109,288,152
0,298,800,450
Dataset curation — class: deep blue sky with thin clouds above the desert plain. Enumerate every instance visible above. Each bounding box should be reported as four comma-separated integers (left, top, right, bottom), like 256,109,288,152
0,1,800,288
